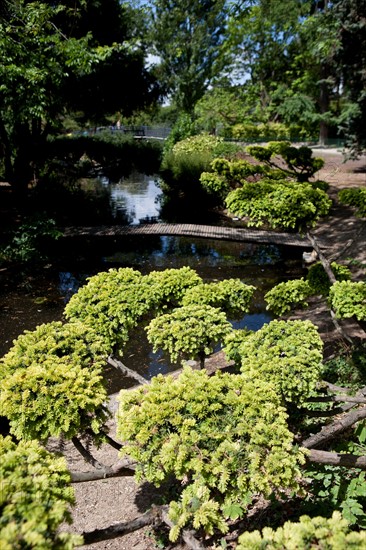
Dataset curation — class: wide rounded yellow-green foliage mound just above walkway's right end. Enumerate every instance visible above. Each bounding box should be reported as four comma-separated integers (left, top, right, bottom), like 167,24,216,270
225,178,331,231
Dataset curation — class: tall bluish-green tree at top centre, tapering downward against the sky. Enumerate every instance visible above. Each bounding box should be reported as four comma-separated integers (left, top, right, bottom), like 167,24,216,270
150,0,226,114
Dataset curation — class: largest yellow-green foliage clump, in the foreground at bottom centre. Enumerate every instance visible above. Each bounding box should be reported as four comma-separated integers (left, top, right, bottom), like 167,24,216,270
118,368,304,541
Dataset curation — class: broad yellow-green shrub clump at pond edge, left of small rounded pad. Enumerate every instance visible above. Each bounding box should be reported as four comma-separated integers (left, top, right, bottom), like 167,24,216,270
65,267,201,353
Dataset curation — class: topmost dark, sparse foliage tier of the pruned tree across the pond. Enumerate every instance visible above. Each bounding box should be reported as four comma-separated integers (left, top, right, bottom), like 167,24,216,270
246,141,324,182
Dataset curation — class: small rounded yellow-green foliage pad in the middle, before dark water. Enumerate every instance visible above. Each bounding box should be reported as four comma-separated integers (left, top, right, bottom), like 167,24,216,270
146,305,232,362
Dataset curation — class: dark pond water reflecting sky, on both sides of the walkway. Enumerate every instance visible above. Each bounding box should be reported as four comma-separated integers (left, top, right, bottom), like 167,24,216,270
0,175,304,391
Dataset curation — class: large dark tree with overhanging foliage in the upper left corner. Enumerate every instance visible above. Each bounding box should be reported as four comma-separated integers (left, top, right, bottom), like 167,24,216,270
0,0,159,192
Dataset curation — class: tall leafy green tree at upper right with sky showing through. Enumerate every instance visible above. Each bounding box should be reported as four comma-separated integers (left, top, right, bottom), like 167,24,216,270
226,0,338,142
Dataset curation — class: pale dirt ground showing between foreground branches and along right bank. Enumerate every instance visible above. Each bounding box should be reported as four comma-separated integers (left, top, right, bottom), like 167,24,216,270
58,150,366,550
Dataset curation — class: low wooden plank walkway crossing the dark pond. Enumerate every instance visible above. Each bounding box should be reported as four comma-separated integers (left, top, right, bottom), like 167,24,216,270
63,223,318,248
